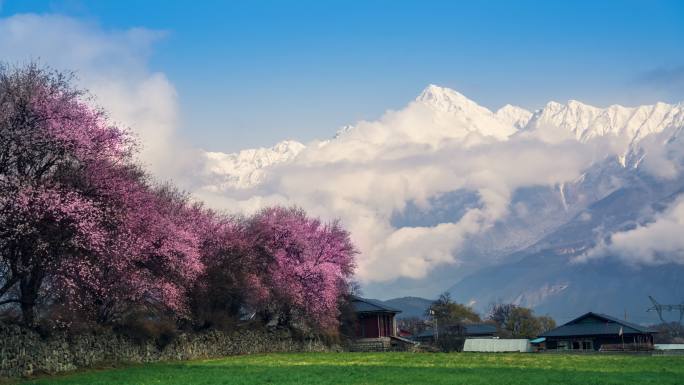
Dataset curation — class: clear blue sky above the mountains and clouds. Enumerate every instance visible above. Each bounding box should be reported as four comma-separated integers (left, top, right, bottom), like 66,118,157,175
0,0,684,151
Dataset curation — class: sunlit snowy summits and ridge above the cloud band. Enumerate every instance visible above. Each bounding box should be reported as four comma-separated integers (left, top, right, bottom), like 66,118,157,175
205,85,684,189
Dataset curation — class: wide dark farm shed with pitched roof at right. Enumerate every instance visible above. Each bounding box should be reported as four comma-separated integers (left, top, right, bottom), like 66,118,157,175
540,312,655,351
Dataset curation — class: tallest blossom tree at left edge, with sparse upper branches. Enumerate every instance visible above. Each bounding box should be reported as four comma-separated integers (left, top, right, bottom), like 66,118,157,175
0,65,123,324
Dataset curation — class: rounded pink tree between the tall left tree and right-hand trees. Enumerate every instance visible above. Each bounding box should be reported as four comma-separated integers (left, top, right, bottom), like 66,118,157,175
71,183,211,323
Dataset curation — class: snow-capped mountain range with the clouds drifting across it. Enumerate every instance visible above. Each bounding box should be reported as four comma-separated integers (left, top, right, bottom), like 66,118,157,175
202,85,684,322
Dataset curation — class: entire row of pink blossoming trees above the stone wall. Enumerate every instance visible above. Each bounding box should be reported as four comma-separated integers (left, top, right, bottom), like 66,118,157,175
0,65,356,328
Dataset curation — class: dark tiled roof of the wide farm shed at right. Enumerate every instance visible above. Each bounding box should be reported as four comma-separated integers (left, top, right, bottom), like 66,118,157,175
540,312,654,337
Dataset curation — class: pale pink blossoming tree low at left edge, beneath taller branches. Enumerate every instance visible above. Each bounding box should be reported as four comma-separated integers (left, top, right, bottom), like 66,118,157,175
0,187,105,324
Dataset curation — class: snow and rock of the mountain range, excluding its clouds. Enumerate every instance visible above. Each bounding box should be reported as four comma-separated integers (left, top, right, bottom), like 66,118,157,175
199,85,684,323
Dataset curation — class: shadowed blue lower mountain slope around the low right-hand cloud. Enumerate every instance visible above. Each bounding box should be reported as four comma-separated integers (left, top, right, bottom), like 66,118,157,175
448,166,684,323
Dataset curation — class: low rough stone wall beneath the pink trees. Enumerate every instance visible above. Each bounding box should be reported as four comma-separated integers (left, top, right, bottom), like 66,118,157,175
0,323,335,378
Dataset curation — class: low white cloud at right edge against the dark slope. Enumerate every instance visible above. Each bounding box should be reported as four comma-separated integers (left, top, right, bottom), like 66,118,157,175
576,195,684,265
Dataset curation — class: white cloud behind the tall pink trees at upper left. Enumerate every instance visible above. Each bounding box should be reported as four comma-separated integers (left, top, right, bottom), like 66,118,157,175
0,14,189,178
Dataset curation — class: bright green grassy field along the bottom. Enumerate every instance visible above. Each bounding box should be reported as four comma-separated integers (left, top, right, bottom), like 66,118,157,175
13,353,684,385
